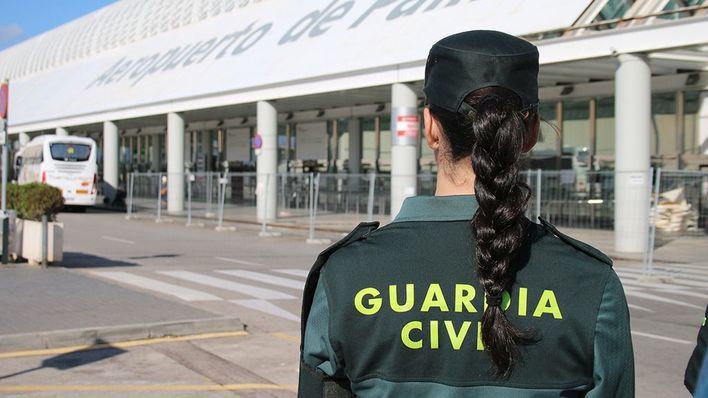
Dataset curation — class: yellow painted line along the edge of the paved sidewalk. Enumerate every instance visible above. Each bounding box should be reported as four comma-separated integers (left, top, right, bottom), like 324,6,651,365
0,331,248,359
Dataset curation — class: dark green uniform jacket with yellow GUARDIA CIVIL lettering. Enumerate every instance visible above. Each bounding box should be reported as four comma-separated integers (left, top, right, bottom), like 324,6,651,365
300,195,634,398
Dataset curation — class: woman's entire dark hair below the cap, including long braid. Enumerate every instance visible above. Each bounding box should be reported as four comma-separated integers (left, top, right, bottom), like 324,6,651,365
429,87,538,378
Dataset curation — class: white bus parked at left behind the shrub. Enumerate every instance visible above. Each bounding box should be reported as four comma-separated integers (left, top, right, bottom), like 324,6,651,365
15,135,98,206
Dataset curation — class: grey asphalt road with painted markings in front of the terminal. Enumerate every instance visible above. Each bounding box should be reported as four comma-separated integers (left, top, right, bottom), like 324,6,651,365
0,212,708,398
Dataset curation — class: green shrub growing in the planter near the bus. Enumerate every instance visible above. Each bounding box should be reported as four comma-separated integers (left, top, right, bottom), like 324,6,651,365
7,183,64,221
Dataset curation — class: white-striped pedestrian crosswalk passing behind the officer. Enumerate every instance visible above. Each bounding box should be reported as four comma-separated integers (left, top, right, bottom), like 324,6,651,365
93,260,708,322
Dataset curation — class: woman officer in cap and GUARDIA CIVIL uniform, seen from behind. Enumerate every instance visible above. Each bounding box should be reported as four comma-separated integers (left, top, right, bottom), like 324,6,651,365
299,31,634,398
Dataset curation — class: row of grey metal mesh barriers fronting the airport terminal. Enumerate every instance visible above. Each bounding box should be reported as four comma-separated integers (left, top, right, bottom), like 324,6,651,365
127,169,708,243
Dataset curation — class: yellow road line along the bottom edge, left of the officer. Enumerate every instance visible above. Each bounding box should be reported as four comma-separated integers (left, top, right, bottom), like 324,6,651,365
0,383,297,393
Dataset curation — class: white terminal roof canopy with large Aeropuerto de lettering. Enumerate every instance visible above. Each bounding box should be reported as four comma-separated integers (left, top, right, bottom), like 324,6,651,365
0,0,589,128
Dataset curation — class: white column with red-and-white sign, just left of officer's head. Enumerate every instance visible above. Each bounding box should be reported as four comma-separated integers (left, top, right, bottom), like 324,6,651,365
391,83,420,219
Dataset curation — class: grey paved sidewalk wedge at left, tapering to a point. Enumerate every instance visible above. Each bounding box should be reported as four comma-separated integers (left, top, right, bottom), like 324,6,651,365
0,266,241,351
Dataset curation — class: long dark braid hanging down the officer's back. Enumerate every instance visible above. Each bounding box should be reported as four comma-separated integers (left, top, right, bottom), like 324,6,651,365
470,91,532,377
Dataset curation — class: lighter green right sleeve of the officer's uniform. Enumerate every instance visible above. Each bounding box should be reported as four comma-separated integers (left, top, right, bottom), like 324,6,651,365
586,271,634,398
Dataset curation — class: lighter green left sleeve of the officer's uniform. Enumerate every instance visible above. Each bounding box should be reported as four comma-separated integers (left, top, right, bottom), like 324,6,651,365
303,275,343,377
